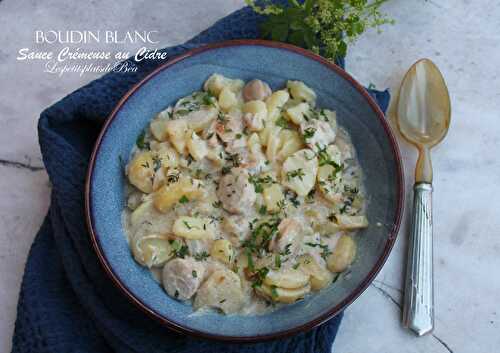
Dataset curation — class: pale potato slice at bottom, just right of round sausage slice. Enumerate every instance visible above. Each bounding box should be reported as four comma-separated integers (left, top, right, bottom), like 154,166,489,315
194,269,244,314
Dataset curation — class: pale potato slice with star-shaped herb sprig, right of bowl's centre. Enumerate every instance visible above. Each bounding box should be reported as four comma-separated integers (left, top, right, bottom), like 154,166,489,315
281,149,318,196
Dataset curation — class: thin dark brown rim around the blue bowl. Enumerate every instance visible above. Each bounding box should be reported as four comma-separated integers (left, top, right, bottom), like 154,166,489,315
85,39,404,343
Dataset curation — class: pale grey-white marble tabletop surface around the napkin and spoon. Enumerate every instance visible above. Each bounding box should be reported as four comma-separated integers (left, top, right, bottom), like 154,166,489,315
0,0,500,353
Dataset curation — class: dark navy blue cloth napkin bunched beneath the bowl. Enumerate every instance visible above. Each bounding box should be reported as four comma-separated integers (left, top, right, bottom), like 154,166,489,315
12,3,389,353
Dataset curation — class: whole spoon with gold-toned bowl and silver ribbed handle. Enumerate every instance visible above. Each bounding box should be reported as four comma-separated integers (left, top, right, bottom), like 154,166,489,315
396,59,451,336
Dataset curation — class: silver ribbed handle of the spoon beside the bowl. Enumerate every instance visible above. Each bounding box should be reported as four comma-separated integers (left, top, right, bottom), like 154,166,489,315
403,183,434,336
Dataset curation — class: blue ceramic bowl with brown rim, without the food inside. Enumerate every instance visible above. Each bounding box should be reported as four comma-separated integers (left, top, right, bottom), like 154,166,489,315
86,40,403,341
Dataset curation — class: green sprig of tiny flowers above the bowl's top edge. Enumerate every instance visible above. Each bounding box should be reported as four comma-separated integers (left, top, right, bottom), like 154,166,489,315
245,0,394,61
